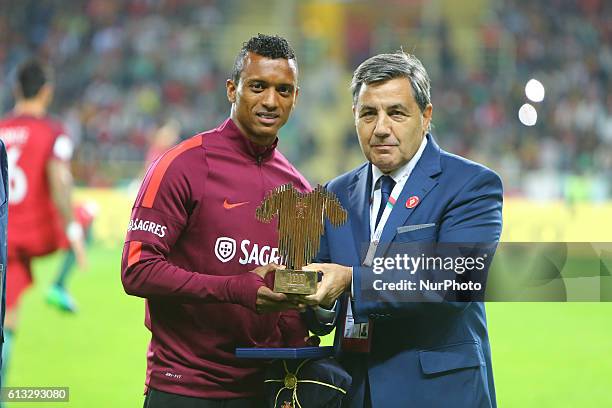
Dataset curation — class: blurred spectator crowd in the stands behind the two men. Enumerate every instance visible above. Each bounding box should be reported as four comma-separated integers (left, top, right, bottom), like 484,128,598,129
0,0,612,200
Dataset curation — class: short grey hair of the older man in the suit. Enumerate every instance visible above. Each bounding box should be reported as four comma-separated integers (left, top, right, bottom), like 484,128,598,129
351,51,431,112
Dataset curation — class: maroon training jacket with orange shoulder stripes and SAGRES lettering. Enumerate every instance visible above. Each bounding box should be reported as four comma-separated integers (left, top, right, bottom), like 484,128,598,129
121,119,310,399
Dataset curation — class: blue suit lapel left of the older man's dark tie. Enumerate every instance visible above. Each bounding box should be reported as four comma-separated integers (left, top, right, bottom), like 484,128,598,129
347,164,372,261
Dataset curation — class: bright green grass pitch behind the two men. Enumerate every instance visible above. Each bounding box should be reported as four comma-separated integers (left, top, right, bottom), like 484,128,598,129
5,246,612,408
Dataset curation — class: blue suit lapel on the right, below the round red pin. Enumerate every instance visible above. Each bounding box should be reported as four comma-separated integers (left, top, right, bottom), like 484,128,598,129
376,134,442,256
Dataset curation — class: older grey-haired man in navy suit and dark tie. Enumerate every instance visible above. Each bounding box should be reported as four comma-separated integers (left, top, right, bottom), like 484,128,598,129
307,52,502,408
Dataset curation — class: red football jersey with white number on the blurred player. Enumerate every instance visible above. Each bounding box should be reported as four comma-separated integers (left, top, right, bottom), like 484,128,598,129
0,115,72,256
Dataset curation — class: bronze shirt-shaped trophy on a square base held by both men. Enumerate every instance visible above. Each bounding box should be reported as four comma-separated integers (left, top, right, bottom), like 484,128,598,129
255,184,347,295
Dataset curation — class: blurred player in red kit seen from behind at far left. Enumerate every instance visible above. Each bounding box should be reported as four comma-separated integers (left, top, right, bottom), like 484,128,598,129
0,60,87,378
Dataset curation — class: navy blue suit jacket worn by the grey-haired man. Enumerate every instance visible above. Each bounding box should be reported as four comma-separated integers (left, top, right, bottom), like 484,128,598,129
311,134,502,408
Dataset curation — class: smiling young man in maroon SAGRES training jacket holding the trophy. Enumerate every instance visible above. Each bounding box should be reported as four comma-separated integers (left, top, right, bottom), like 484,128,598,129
122,34,310,408
